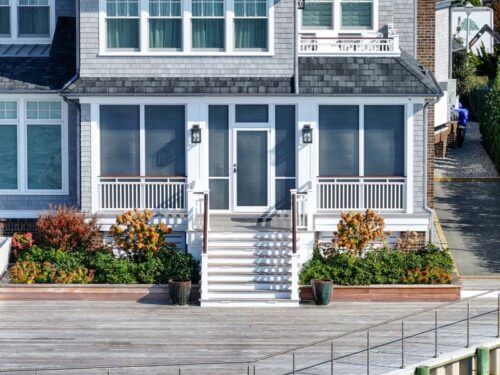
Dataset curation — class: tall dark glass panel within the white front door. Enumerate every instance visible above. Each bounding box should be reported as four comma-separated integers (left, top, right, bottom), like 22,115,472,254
236,130,268,207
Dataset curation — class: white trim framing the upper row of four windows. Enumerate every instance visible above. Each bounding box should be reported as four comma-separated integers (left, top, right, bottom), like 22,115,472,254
97,0,274,57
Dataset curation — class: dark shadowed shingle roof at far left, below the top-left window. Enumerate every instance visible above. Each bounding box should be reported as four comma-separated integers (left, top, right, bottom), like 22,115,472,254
0,17,76,92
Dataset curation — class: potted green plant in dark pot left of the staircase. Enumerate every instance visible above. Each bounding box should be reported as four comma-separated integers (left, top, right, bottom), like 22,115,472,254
168,251,193,306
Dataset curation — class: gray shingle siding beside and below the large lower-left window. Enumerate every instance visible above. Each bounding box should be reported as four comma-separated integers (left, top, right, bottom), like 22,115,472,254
0,106,78,211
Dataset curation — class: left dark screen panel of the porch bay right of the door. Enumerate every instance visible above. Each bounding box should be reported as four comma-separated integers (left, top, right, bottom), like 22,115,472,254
319,105,359,177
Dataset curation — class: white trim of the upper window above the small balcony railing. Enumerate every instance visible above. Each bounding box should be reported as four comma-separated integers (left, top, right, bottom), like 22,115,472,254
298,0,379,37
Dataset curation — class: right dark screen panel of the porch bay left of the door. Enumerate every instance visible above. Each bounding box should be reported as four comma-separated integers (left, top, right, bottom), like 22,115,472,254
145,105,186,176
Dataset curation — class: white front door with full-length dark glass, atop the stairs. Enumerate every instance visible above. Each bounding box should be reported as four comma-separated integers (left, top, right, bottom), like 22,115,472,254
232,129,270,212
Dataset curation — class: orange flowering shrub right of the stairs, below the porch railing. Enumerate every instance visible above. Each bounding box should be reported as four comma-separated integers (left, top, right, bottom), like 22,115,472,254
334,209,389,255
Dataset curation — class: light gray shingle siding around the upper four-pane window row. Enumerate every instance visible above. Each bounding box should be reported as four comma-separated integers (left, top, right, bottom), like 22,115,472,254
80,0,294,77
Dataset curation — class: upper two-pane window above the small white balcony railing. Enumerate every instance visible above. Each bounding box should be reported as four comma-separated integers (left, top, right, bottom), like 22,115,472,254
301,0,378,32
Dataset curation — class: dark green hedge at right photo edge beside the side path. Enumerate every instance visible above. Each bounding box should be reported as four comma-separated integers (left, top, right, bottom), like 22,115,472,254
479,68,500,170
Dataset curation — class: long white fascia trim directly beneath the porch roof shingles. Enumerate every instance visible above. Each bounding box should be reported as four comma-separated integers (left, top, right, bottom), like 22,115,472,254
79,95,425,105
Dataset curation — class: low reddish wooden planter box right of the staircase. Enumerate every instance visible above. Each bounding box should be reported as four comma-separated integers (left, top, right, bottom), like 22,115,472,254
300,284,462,302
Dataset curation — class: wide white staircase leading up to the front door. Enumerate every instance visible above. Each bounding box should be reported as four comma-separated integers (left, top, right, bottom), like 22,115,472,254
201,231,299,307
